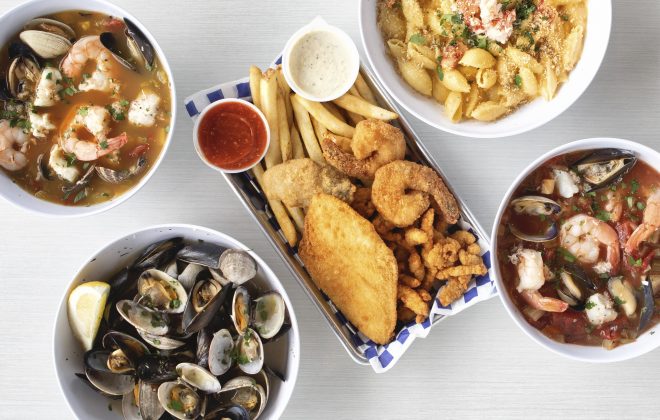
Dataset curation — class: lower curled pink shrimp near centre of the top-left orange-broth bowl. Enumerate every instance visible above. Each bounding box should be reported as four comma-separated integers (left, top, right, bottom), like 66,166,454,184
60,106,128,161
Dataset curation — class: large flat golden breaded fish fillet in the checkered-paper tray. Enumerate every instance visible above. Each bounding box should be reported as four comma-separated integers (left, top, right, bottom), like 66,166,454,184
299,194,398,344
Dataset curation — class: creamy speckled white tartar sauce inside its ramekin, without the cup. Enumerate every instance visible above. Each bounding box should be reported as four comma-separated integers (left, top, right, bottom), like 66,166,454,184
289,30,355,98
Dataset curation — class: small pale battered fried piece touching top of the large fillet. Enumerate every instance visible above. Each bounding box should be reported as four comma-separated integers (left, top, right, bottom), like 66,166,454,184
263,158,356,207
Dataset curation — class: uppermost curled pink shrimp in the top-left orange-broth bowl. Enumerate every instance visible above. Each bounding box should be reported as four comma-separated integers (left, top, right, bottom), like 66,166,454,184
60,35,116,92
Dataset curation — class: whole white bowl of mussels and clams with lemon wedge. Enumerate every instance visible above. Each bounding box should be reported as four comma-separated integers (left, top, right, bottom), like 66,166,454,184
54,225,300,420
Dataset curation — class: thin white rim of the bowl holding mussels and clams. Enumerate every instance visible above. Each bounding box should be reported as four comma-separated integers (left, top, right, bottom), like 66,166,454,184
51,223,300,418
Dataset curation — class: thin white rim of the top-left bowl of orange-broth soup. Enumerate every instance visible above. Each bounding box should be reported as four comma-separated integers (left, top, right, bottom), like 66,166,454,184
0,0,177,218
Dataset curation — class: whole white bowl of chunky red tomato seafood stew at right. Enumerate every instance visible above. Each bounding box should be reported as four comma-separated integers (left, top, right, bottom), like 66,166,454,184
492,138,660,362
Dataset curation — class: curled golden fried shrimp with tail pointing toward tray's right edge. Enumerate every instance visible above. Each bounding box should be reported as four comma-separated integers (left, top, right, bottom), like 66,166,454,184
371,160,460,227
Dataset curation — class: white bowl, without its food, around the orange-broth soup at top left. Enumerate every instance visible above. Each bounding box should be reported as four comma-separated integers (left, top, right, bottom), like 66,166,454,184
0,0,177,217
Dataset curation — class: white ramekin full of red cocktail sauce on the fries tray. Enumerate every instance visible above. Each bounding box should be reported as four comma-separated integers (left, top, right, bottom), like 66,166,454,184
193,99,270,173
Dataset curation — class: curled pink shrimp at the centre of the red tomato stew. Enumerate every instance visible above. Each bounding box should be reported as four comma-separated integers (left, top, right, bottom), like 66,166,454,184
559,214,621,274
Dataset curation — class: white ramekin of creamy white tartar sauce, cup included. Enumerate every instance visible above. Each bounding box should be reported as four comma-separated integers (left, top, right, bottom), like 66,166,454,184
282,18,360,102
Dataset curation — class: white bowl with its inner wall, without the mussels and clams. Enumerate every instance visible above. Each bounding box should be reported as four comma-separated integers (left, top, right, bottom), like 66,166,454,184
53,225,300,420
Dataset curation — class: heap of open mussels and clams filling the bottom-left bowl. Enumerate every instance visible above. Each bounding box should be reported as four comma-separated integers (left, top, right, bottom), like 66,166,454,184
68,237,291,420
